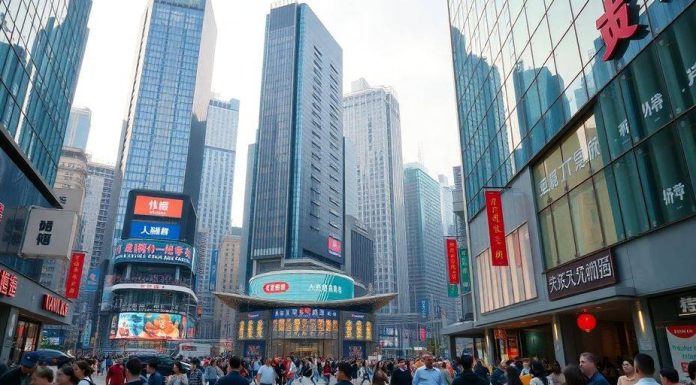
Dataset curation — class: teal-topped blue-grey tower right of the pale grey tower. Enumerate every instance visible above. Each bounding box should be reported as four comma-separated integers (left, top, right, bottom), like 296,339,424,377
404,164,454,319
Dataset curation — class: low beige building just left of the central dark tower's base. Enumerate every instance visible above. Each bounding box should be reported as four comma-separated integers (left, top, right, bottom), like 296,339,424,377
209,227,243,340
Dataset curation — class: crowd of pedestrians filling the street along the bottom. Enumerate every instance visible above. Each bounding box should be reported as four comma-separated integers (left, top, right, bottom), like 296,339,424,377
0,352,696,385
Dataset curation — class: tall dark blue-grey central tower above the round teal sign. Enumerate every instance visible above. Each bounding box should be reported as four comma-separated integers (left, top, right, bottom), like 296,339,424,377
247,4,344,274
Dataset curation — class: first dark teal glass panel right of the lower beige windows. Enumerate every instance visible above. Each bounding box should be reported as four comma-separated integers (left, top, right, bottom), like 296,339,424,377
613,152,649,237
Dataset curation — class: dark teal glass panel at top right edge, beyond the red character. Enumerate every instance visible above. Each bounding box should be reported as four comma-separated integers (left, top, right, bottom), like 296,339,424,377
651,3,696,114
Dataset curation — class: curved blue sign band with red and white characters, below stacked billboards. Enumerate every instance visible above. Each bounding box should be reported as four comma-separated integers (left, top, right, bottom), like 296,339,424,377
114,239,194,268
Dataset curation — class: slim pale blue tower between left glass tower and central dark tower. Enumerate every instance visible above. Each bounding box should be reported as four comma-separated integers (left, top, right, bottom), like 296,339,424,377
196,99,239,339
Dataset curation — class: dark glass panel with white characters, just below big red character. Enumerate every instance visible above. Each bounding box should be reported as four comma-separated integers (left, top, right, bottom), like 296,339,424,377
619,46,672,138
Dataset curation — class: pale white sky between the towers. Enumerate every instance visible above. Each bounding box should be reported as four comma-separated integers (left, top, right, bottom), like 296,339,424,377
73,0,461,227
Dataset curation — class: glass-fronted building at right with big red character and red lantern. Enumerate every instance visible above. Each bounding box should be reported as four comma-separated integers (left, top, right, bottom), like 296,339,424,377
447,0,696,366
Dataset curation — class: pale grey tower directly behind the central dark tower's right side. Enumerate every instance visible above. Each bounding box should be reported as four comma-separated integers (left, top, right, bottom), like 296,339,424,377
343,79,410,313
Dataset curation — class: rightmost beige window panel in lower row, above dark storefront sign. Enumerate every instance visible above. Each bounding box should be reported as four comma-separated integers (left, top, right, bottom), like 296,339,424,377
569,180,604,255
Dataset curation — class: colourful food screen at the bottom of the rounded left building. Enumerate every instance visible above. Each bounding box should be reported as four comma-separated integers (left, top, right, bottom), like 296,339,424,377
109,313,186,340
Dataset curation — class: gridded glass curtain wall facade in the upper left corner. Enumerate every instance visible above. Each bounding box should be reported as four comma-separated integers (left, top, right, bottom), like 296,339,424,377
0,0,92,185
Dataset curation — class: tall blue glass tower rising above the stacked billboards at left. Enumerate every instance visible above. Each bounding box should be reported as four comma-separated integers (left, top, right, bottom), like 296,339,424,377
113,0,217,243
